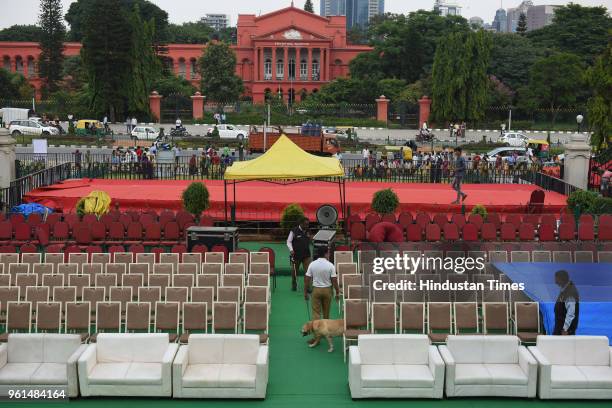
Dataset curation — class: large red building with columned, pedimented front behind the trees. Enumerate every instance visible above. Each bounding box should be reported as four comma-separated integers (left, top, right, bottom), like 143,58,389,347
0,6,371,102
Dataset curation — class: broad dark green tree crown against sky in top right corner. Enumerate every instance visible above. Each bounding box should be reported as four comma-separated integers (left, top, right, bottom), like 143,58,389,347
527,3,612,64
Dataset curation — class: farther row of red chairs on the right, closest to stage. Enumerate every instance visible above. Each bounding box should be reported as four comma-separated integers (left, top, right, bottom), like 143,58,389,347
348,212,612,231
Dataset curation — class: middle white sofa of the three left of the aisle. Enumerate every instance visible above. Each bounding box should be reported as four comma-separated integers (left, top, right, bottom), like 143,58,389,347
79,333,178,397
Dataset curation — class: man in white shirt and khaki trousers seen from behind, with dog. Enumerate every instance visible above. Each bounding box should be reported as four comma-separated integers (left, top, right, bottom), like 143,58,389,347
304,248,340,320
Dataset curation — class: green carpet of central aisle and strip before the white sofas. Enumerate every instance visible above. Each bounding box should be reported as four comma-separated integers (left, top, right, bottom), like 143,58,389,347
7,276,610,408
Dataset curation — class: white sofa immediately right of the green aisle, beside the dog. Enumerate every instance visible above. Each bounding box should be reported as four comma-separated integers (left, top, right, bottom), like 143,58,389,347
349,334,444,399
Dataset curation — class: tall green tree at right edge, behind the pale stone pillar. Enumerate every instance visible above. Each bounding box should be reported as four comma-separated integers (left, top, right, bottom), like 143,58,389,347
585,33,612,150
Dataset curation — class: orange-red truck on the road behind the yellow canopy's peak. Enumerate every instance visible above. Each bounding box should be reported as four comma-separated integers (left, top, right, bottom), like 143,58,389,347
249,126,340,156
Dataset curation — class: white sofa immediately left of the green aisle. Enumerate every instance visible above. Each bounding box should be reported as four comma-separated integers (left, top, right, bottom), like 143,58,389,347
172,334,268,399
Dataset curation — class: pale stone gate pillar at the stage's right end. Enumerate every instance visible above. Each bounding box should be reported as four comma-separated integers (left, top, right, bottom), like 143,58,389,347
563,133,591,190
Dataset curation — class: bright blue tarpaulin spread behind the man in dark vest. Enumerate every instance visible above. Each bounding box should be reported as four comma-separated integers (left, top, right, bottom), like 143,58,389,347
494,262,612,339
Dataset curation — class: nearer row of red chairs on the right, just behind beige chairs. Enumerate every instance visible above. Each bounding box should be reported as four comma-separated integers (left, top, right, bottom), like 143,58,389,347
350,222,612,242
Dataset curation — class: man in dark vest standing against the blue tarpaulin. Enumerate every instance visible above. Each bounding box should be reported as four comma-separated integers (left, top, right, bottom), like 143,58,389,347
553,270,580,336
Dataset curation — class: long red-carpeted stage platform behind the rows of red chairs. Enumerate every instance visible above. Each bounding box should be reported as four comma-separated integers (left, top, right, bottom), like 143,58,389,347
24,179,566,221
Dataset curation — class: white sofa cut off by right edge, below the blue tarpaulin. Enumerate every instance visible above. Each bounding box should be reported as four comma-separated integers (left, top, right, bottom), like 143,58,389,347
529,336,612,399
